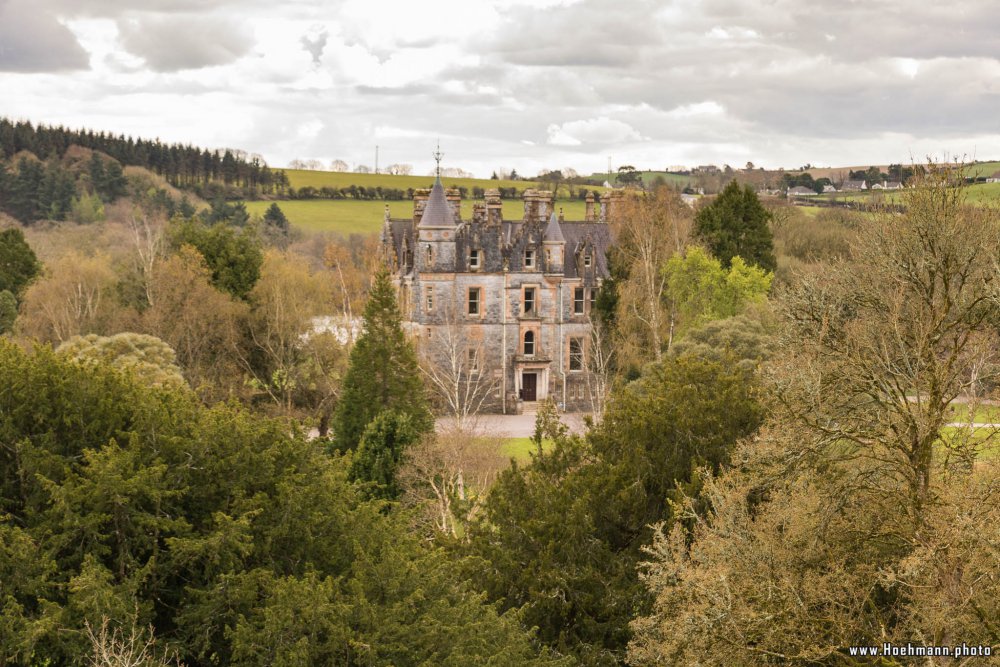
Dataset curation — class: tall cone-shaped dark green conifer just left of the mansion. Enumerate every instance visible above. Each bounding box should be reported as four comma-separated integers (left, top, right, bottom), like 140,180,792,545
334,269,434,451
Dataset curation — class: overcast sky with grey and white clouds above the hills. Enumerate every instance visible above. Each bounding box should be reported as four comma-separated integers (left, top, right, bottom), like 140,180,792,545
0,0,1000,176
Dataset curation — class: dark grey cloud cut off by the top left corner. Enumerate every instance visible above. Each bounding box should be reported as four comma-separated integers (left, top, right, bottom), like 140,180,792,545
0,0,89,72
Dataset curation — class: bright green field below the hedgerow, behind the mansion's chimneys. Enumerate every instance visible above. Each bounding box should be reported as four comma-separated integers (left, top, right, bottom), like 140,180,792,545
246,198,586,235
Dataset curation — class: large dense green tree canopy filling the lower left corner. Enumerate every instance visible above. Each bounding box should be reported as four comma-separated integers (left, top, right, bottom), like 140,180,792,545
0,342,565,667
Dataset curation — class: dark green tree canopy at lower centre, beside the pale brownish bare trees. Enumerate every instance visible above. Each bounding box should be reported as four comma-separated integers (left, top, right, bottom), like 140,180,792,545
469,357,762,665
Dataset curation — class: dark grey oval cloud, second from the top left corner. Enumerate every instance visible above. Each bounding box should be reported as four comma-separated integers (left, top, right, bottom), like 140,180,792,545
118,16,253,72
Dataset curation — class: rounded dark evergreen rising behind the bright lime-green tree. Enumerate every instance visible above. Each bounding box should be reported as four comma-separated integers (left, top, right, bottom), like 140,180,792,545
694,181,777,271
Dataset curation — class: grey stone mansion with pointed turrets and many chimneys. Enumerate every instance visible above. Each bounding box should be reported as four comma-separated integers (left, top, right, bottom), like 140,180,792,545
382,178,620,413
